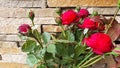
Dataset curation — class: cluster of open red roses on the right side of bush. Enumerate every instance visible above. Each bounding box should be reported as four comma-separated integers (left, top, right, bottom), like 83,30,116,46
61,9,113,55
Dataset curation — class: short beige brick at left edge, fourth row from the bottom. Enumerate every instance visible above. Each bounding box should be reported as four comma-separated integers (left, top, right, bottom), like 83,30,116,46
0,41,17,48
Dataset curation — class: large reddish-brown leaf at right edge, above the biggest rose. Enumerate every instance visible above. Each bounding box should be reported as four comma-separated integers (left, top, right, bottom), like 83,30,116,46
107,18,120,41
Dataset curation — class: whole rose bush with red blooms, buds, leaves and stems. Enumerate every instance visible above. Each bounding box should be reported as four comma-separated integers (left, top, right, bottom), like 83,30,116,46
18,3,120,68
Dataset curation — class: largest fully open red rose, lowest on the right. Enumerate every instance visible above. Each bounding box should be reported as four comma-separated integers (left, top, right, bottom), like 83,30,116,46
84,33,113,55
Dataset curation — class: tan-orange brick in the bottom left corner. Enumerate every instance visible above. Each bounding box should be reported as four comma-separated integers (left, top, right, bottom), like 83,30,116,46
0,62,30,68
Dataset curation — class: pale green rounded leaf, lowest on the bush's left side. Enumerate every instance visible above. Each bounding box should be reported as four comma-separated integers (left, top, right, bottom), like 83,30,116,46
27,54,38,67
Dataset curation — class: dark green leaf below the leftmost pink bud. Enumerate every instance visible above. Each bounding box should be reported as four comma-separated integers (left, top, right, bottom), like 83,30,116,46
22,39,37,52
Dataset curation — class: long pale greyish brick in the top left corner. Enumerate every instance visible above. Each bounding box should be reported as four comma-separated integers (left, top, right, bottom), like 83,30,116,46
0,0,46,8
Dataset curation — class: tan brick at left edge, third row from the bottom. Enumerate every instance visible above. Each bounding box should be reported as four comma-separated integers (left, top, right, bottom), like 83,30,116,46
0,47,21,54
